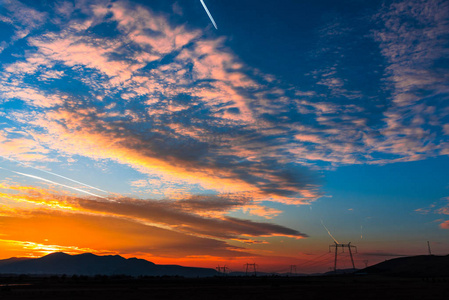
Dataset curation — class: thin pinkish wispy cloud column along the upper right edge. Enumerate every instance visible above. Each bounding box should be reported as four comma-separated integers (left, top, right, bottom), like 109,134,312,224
374,1,449,160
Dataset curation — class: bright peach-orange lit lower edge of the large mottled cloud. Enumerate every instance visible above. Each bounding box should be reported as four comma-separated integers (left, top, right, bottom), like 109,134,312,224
31,110,256,192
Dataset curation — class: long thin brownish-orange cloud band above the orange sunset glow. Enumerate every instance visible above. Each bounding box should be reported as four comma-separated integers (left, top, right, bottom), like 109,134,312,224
0,187,303,243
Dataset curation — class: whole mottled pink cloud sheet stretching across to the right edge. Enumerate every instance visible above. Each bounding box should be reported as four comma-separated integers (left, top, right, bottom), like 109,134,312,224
0,1,449,211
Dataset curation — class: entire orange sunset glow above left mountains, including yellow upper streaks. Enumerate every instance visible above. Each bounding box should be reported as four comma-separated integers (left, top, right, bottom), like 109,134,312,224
0,185,316,269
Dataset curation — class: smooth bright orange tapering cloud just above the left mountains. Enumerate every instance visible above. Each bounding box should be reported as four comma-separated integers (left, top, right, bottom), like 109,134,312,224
0,206,248,257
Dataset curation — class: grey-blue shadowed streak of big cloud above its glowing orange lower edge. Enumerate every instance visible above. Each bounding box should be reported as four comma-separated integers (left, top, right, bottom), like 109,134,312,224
44,95,319,203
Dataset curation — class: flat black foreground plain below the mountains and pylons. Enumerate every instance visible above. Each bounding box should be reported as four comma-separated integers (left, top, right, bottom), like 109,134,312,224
0,275,449,300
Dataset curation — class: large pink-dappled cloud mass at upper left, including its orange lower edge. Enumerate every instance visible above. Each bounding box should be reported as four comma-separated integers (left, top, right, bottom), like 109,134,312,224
3,2,315,203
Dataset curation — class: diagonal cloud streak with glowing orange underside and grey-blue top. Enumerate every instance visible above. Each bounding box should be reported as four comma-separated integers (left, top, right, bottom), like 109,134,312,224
23,106,316,204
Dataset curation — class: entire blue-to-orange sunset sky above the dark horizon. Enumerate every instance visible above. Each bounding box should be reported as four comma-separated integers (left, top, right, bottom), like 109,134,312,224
0,0,449,273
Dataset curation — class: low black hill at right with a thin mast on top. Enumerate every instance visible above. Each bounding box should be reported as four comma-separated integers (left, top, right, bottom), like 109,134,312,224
358,255,449,277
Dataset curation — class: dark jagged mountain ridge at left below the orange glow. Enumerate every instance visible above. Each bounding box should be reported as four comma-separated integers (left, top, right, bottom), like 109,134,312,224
0,252,218,277
